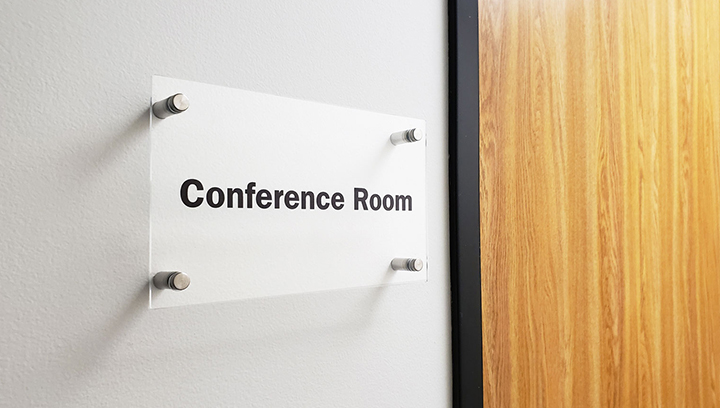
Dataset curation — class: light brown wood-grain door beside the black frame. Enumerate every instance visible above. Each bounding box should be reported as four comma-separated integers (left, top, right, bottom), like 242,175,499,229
479,0,720,407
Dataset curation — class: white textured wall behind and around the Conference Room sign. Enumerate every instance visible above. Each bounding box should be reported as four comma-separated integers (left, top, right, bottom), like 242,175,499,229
0,0,451,408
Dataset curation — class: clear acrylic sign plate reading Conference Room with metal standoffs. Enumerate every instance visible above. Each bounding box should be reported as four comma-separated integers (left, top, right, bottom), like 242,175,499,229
149,76,428,308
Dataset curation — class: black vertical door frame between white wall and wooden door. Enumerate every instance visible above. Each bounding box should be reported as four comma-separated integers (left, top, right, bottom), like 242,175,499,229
448,0,483,408
